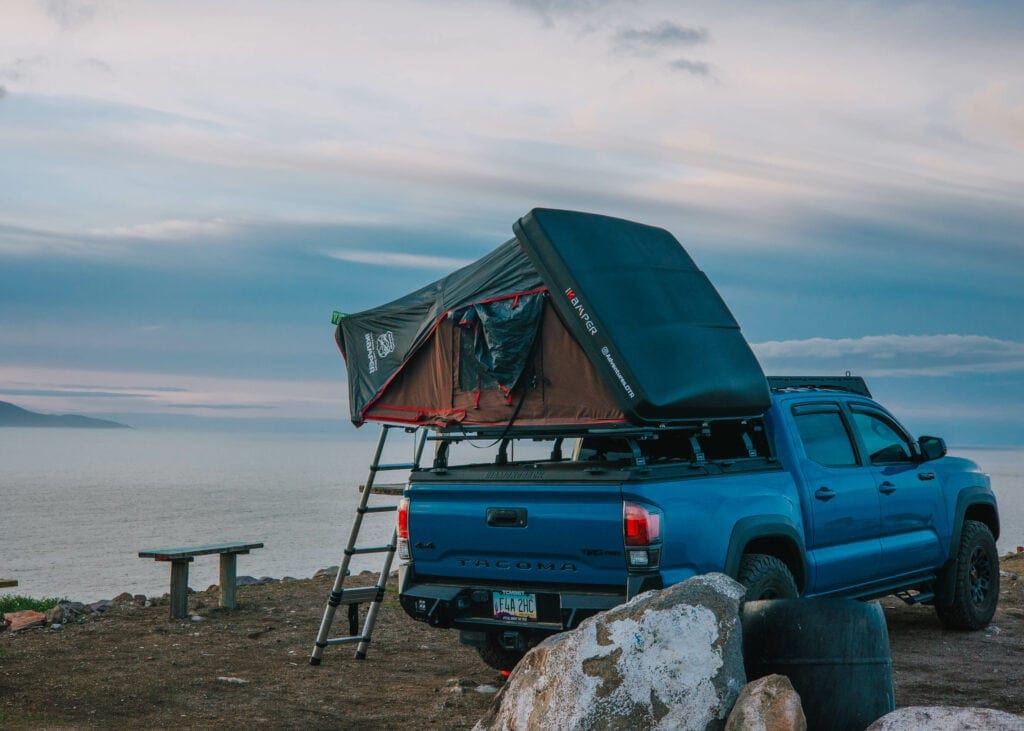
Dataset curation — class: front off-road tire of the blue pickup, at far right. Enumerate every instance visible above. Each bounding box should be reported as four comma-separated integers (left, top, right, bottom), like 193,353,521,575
935,520,999,630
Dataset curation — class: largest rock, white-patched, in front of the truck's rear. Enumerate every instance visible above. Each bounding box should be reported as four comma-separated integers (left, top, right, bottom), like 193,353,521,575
476,573,746,729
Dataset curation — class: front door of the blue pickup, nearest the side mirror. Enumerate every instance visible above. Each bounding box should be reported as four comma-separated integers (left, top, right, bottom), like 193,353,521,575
850,403,948,576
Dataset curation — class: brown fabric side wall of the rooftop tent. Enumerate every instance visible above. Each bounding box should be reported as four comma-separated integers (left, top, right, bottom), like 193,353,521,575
364,301,626,428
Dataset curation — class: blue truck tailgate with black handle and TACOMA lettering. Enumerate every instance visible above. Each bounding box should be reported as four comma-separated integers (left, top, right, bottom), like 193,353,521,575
407,482,627,586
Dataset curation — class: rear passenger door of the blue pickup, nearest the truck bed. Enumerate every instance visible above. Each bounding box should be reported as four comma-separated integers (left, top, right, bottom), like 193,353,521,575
793,402,882,594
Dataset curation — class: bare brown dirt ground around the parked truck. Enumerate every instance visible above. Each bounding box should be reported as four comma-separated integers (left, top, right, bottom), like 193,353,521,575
0,557,1024,729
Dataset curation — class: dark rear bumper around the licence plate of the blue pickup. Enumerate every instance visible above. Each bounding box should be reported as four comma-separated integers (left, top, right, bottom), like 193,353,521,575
398,564,662,634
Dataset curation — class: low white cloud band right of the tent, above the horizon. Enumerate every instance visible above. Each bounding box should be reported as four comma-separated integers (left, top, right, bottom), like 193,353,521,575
751,335,1024,377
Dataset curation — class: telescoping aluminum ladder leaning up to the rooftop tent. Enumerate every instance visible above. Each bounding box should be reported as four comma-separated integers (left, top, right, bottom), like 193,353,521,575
309,417,427,665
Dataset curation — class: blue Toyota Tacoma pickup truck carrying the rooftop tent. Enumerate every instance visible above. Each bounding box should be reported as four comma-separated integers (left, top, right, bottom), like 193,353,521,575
398,379,999,670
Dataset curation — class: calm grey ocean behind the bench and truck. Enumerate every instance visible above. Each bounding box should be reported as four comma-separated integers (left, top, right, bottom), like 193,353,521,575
0,427,1024,601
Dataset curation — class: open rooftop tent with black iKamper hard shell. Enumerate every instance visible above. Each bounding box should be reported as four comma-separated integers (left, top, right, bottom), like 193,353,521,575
336,209,768,430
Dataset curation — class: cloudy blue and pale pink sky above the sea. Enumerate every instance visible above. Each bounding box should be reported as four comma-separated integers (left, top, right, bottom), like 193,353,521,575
0,0,1024,445
